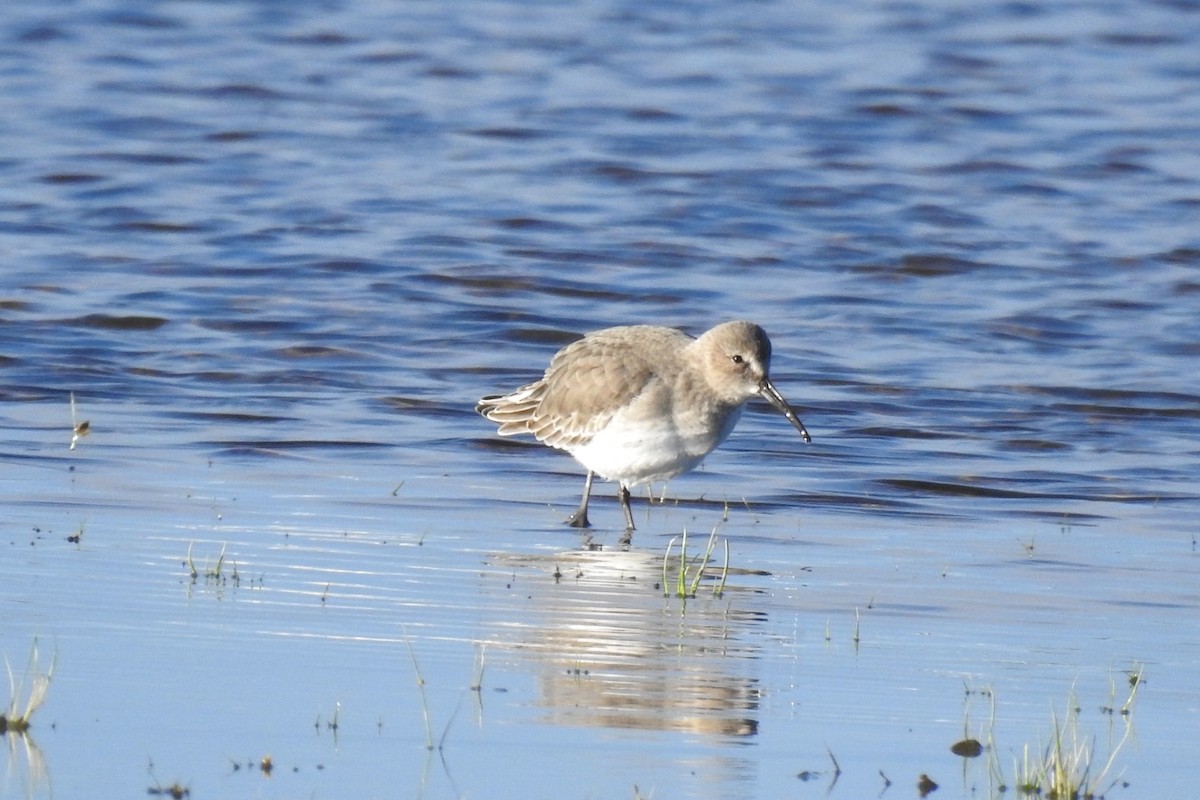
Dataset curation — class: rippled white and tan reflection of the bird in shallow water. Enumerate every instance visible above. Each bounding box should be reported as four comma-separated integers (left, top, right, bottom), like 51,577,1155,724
494,551,764,736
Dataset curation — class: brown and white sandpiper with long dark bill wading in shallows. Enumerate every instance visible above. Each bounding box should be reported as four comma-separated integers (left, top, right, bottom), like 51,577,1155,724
475,321,811,531
